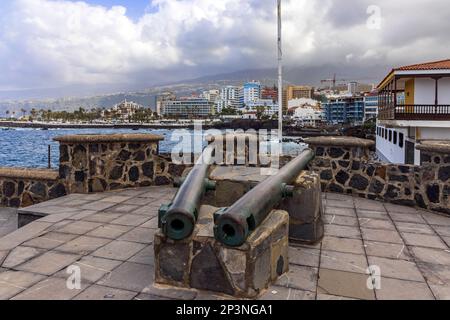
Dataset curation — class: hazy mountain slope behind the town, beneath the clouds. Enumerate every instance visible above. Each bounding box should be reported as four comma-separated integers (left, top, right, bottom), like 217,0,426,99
0,65,389,115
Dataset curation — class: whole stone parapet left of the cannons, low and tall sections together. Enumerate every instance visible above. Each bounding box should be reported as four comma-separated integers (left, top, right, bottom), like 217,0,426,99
0,134,187,207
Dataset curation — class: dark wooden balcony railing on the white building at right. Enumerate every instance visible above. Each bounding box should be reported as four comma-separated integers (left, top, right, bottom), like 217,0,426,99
379,104,450,121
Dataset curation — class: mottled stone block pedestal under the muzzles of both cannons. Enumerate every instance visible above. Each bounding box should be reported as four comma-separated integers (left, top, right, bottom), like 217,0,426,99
154,205,289,298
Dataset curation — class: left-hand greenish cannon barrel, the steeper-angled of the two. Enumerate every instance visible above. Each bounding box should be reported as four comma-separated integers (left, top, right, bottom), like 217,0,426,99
159,147,215,240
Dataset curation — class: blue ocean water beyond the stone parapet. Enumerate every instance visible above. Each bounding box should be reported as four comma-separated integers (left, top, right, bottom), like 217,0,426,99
0,128,305,168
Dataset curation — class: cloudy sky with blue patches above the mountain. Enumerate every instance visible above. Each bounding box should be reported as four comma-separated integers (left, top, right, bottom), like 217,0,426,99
0,0,450,97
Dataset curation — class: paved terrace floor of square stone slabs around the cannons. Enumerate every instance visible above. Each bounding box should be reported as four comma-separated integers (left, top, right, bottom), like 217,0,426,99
0,187,450,300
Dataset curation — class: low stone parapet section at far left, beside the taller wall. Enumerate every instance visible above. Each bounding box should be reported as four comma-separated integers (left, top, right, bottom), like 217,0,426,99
0,168,67,207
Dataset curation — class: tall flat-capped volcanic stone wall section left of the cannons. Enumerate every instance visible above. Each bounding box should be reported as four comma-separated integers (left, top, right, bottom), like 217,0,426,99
56,134,188,193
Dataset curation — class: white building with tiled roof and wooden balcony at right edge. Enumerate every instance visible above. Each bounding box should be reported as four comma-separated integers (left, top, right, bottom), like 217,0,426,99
377,59,450,165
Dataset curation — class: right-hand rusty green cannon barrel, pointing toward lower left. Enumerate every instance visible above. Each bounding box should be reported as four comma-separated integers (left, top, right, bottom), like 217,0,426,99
214,149,315,247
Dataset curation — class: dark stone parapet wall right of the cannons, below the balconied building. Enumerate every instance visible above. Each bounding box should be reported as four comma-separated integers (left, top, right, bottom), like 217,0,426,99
306,137,450,214
